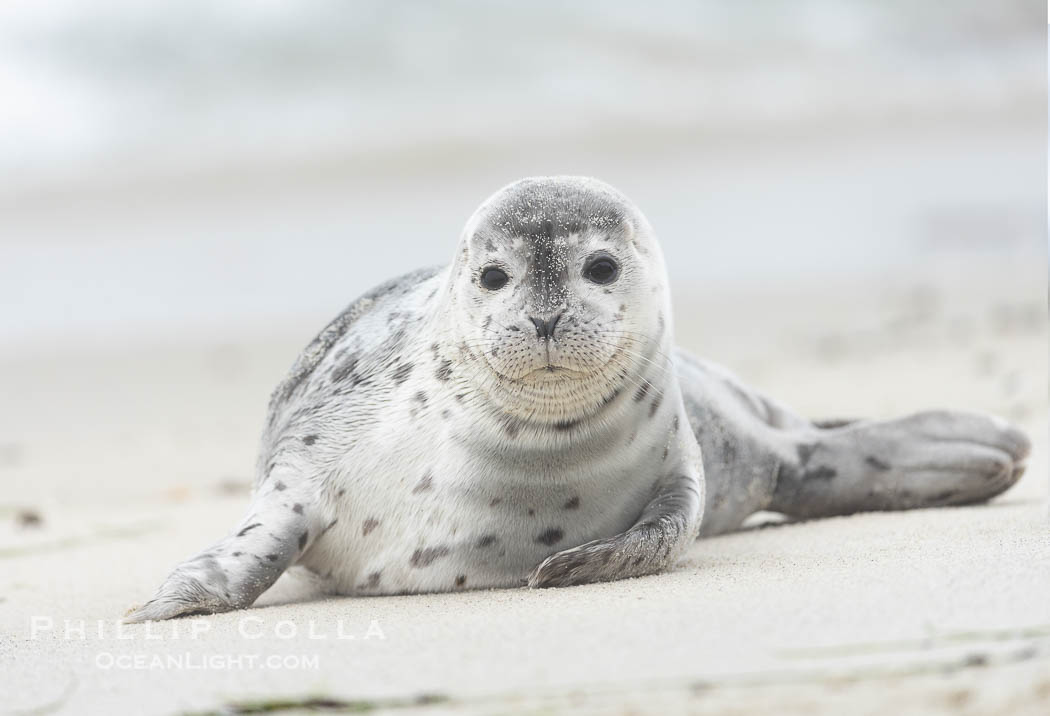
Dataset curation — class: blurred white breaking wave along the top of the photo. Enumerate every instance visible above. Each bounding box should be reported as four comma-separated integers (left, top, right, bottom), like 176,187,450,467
0,0,1046,182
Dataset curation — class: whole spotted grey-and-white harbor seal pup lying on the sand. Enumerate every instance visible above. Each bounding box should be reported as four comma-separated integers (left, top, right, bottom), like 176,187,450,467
128,177,1029,622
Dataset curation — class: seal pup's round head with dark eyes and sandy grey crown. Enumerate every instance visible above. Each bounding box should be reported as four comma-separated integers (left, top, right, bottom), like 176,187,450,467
448,176,671,423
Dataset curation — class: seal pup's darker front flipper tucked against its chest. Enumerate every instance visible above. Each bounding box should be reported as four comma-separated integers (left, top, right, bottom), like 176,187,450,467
528,475,704,587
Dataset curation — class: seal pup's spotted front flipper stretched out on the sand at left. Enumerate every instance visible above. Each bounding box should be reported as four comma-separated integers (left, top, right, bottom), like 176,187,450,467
124,481,317,623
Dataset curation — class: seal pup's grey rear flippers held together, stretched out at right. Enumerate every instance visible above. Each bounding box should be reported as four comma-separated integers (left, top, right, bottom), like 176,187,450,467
769,410,1031,518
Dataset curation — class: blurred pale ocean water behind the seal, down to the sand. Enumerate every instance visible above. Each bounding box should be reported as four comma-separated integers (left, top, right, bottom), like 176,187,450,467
0,0,1047,349
